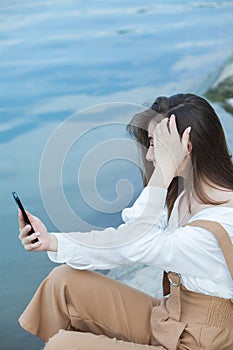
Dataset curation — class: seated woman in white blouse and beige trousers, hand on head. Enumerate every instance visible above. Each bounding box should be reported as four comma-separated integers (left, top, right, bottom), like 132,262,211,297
19,94,233,350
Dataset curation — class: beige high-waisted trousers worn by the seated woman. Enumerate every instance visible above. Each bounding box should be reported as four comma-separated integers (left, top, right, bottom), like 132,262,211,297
19,265,233,350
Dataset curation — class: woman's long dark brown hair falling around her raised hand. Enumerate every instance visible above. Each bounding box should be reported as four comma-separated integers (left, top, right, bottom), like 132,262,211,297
127,93,233,216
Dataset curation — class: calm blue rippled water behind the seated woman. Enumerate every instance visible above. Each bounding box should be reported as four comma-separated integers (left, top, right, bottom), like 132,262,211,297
0,0,233,350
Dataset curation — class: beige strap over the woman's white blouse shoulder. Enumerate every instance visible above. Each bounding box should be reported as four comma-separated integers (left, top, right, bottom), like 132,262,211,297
185,220,233,279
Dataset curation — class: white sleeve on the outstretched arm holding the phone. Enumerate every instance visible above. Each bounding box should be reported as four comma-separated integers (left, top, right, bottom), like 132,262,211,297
47,220,229,280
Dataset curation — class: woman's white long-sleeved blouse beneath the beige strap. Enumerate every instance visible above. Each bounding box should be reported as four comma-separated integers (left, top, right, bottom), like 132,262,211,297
48,187,233,298
